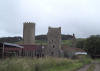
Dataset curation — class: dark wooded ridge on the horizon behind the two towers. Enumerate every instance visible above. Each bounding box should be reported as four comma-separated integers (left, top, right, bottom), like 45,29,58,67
0,35,73,43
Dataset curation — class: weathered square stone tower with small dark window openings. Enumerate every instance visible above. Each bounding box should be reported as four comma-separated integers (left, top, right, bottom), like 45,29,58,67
47,27,61,57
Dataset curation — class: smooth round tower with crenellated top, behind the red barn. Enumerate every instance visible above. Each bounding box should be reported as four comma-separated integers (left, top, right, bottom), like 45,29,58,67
23,22,35,45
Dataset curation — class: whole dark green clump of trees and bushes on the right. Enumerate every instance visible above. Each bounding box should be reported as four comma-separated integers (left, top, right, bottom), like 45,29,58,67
76,35,100,58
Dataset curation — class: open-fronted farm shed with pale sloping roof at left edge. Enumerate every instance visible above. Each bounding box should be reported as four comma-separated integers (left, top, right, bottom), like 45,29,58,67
0,43,23,58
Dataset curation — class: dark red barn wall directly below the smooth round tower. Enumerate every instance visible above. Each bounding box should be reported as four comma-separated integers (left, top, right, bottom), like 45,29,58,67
21,45,44,57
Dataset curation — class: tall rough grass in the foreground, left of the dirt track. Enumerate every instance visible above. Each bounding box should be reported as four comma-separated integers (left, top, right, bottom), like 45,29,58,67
0,57,90,71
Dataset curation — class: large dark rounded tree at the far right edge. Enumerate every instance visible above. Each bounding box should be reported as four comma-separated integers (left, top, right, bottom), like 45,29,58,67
84,35,100,57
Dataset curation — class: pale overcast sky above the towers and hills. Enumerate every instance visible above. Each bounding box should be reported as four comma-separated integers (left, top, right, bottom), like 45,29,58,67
0,0,100,38
